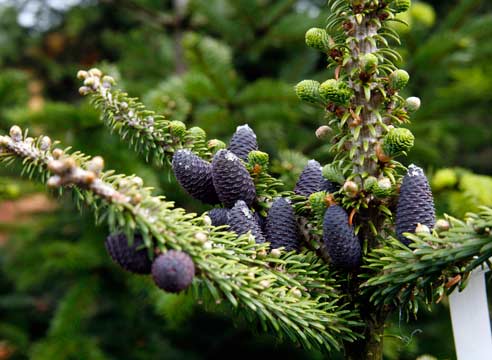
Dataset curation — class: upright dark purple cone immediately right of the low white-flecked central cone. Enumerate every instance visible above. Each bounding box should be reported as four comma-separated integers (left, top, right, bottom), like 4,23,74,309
265,198,299,251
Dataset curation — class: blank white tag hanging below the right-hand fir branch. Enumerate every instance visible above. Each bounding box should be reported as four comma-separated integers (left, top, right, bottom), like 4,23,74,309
449,269,492,360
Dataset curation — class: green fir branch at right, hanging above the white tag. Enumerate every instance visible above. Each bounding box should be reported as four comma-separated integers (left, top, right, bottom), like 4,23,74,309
361,208,492,312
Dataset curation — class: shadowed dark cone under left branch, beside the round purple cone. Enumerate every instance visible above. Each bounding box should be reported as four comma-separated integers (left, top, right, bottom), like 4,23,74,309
105,233,152,274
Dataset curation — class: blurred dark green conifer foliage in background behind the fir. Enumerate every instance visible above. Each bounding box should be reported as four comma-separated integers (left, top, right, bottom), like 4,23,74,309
0,0,492,360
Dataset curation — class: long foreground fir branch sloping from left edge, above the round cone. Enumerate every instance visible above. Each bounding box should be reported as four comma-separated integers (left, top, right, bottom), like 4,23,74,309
0,126,360,350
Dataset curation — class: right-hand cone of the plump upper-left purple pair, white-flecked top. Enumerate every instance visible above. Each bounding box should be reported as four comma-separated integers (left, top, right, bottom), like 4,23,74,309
212,150,256,208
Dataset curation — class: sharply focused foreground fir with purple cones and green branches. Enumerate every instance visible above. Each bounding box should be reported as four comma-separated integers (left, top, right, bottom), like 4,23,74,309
0,0,492,359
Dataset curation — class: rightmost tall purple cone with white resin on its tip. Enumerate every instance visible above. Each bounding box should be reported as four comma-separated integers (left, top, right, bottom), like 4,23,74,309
396,165,436,245
